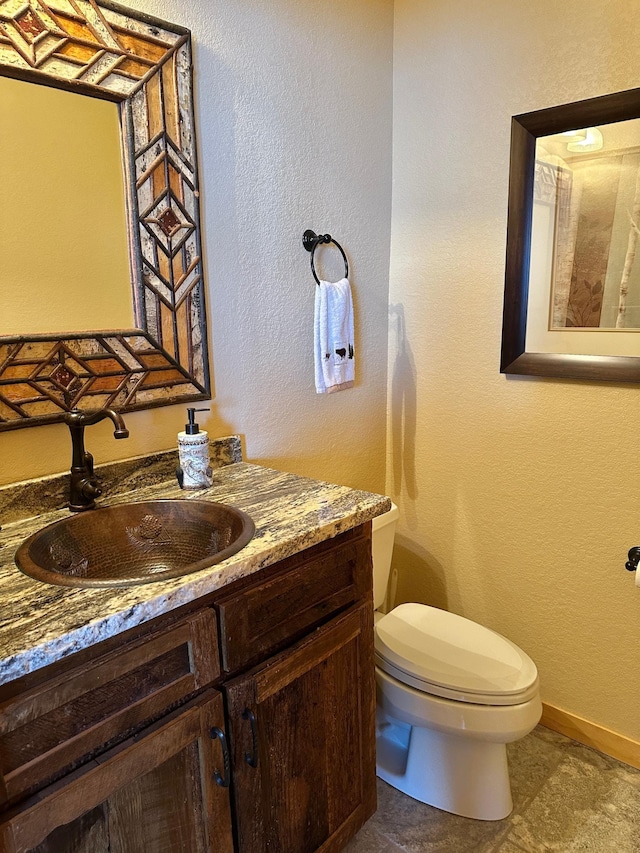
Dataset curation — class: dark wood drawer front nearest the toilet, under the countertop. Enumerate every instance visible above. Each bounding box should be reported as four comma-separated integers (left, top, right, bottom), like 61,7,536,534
217,535,371,673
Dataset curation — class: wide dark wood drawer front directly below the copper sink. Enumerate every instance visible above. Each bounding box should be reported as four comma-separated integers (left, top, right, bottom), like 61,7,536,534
0,610,219,802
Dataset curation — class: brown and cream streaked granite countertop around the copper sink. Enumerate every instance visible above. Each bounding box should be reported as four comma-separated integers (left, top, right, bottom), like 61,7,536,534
0,462,390,684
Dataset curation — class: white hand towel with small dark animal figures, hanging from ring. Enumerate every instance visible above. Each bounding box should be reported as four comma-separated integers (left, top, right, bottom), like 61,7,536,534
314,278,355,394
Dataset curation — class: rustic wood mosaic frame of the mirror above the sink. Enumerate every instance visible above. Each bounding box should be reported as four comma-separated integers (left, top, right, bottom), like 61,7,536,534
0,0,210,430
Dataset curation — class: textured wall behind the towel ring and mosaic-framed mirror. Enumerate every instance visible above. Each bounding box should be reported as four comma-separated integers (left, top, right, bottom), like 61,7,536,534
0,0,393,491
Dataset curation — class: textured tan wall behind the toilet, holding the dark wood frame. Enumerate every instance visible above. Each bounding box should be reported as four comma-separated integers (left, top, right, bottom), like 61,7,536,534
388,0,640,738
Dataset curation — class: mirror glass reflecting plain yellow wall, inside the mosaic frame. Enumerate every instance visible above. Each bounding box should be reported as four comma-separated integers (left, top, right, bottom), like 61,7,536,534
0,77,135,335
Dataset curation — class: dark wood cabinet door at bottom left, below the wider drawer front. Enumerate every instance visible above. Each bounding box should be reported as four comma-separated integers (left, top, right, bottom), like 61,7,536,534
0,690,233,853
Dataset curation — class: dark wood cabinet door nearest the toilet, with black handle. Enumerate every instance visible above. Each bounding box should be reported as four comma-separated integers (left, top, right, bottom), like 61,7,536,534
225,604,376,853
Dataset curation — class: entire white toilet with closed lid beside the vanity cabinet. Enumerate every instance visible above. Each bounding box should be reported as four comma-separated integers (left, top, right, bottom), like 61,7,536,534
373,506,542,820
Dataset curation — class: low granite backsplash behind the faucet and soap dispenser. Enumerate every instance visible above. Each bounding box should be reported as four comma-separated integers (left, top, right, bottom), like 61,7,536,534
0,435,242,525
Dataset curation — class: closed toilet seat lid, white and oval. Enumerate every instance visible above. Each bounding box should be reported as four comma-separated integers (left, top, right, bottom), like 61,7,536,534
375,604,538,705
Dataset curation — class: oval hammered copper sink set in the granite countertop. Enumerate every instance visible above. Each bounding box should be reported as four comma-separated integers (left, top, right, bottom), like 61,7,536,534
15,500,255,587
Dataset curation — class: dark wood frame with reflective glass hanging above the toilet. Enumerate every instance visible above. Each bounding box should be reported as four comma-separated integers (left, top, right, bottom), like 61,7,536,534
500,89,640,382
